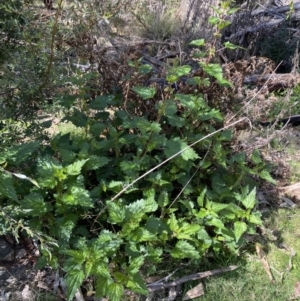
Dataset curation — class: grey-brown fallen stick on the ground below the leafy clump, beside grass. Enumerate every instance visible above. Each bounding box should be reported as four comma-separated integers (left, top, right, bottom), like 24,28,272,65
147,265,238,293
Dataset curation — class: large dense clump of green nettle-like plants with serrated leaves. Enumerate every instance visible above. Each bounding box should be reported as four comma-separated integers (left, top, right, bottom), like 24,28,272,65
0,1,272,301
